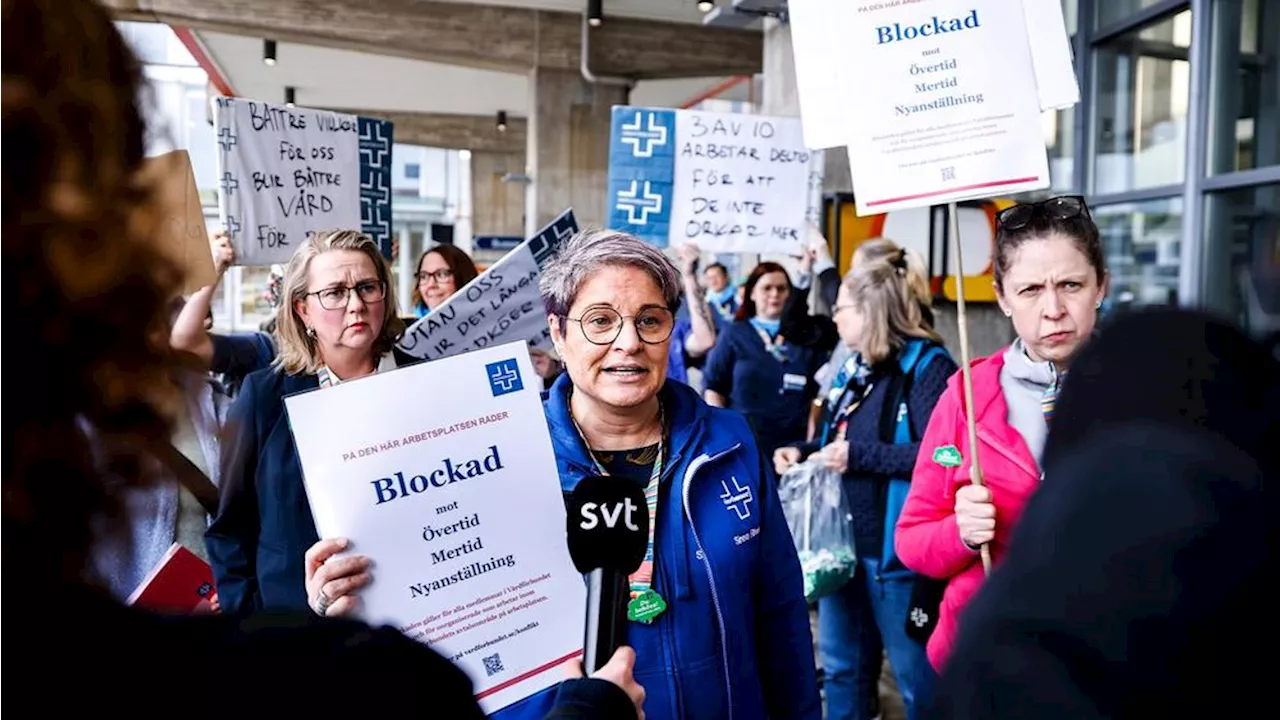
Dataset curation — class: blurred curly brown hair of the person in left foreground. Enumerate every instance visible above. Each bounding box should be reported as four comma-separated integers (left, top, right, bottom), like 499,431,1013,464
0,0,180,584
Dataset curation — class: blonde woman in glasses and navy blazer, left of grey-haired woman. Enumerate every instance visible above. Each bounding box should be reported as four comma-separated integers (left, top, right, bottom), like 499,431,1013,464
205,231,404,614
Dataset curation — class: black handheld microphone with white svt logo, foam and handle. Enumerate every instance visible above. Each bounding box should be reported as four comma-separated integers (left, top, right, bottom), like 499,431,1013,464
568,477,649,673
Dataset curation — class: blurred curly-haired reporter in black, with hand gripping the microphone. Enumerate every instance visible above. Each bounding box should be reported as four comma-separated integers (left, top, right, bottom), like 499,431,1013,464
0,0,644,720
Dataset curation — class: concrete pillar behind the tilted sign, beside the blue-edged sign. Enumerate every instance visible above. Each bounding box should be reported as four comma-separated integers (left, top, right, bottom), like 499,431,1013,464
525,68,628,236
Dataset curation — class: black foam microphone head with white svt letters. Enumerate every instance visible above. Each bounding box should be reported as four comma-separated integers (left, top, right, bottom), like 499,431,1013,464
567,477,649,575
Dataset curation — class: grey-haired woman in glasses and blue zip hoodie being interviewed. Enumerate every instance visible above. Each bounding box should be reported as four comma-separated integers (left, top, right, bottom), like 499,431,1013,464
529,231,822,720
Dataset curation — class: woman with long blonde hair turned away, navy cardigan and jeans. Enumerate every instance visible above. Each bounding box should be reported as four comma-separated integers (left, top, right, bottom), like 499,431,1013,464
773,250,956,720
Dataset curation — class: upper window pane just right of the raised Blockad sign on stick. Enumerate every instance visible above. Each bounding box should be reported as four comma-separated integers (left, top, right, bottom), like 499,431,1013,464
1091,10,1192,195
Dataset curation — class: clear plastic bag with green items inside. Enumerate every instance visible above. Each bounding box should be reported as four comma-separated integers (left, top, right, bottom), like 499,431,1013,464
778,461,858,602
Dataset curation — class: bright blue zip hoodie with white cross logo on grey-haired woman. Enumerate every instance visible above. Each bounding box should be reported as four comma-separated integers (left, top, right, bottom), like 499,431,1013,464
532,374,822,720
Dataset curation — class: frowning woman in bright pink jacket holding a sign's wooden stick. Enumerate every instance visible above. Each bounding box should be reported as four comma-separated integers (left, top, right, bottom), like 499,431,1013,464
896,196,1107,669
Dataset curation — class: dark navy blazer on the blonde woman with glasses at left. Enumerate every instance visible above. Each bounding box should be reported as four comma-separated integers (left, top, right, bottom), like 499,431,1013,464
205,368,320,614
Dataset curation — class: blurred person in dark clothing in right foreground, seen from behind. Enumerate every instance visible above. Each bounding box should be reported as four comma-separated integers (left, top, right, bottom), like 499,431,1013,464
931,310,1280,720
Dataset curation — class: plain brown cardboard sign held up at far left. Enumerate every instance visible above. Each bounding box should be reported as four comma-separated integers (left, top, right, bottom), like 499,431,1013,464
141,150,218,293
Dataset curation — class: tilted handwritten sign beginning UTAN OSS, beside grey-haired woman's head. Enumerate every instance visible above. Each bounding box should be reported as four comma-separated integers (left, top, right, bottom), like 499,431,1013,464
397,210,577,360
